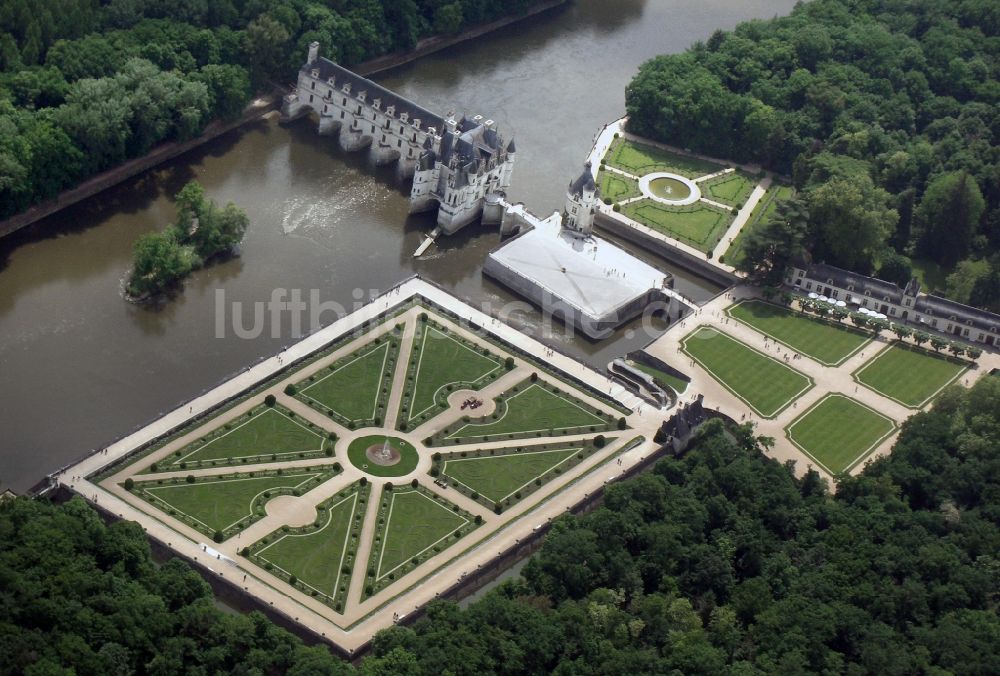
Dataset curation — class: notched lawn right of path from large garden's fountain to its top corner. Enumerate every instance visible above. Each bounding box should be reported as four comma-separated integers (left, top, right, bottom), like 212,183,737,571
400,322,504,427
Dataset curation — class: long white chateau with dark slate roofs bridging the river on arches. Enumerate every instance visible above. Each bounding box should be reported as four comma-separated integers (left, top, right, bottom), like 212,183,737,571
282,42,515,234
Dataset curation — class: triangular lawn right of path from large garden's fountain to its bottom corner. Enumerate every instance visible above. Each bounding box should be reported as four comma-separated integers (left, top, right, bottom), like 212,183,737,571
369,489,469,581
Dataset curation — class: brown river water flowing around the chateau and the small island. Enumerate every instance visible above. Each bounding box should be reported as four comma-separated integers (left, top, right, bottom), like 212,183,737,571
0,0,794,491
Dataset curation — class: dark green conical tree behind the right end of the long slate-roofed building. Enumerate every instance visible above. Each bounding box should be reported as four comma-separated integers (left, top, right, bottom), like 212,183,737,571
915,171,986,266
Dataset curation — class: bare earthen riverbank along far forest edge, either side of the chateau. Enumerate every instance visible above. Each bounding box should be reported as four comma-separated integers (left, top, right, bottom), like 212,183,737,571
0,0,567,243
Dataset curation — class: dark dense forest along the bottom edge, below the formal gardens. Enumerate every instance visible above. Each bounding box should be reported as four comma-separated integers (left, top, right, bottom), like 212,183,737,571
0,377,1000,676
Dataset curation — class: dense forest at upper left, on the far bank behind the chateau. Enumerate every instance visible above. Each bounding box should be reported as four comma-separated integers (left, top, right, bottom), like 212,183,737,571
0,0,531,218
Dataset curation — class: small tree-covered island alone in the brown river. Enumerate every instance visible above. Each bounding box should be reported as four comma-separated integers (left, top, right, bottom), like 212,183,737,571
125,181,249,301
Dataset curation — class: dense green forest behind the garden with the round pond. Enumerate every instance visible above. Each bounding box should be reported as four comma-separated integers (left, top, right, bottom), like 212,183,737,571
626,0,1000,309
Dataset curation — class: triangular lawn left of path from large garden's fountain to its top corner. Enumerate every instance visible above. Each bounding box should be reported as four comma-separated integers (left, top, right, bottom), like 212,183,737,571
296,339,398,425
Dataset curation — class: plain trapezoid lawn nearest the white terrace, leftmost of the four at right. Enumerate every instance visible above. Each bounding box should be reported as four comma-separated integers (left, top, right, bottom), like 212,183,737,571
681,327,813,418
